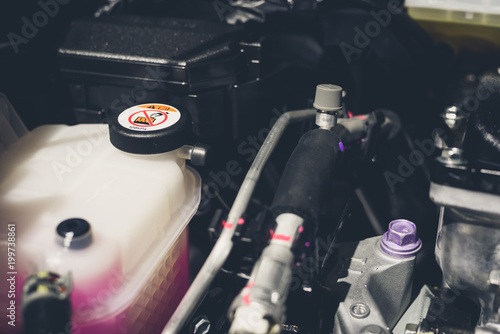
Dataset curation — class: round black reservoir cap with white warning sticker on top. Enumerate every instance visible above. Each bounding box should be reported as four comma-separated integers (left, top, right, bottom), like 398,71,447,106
109,103,191,154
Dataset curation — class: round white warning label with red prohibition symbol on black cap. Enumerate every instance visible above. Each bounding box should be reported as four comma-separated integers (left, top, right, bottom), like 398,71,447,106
118,103,181,131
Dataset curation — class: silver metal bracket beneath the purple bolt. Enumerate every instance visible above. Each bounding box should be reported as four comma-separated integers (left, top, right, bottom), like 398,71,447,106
326,227,416,334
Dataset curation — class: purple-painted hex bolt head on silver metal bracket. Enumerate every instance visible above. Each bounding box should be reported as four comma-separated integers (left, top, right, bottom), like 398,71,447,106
380,219,422,257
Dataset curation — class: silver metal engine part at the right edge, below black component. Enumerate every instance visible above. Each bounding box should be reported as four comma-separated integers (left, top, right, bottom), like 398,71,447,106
430,183,500,333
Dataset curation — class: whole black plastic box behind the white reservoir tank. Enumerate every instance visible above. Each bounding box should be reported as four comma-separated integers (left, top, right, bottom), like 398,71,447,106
58,15,250,138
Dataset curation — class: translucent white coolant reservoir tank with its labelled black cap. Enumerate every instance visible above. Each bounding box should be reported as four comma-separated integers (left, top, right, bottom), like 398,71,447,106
0,103,201,334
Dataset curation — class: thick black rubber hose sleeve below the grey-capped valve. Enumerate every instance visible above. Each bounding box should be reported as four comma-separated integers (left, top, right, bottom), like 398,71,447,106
271,129,343,221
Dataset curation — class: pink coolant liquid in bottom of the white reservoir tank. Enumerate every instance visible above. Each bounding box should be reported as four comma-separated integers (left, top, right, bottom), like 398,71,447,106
12,229,189,334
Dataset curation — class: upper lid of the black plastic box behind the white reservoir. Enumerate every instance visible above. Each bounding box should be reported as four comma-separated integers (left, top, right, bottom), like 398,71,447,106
58,15,242,92
